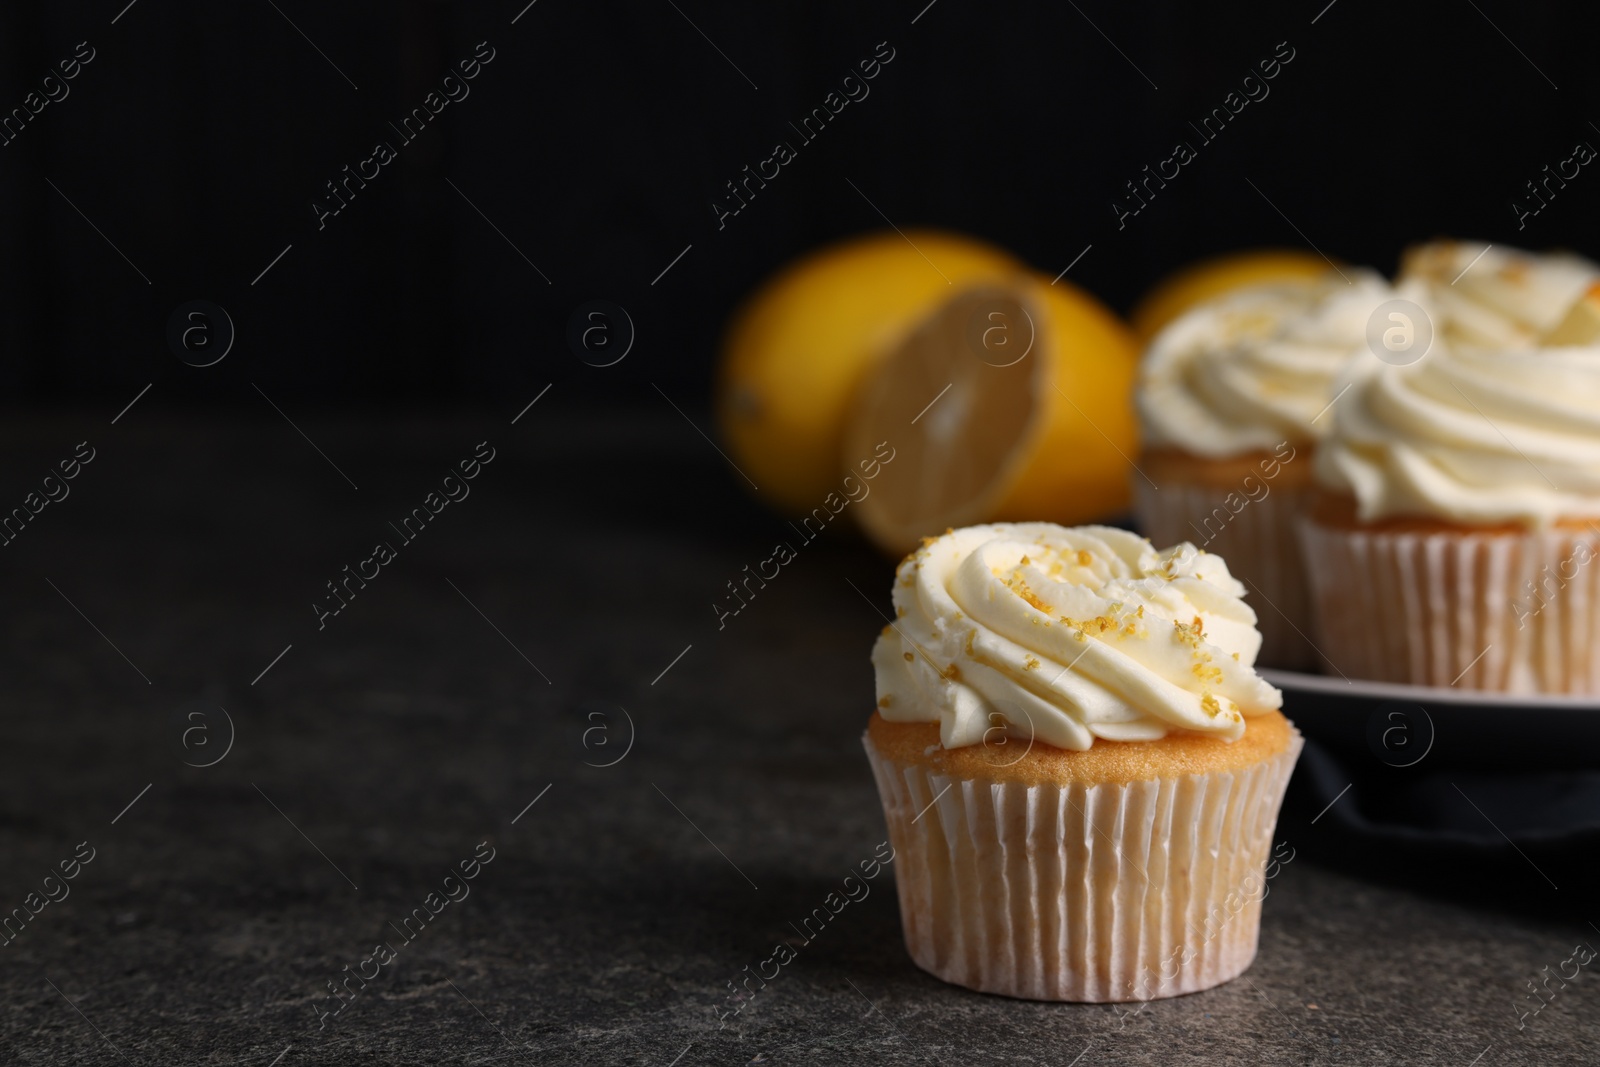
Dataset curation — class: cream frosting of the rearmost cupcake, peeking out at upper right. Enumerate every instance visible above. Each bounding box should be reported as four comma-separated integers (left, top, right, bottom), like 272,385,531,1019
1395,240,1600,349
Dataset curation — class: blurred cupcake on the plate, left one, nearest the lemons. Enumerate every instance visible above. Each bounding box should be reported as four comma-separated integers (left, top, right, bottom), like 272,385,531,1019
1133,269,1394,667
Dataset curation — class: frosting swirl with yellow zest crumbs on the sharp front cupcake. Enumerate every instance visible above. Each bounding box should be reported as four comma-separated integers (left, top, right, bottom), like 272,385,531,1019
872,523,1283,750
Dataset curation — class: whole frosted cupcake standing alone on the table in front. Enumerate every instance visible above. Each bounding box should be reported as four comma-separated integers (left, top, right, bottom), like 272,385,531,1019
864,523,1302,1001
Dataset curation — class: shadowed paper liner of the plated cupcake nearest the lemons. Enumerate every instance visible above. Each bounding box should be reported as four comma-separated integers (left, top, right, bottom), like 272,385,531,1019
1134,478,1318,669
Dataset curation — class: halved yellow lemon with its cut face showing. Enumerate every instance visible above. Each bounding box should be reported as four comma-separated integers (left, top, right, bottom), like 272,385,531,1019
843,274,1138,553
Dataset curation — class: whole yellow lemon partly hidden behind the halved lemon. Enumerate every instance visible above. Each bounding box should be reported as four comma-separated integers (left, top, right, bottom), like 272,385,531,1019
715,230,1024,515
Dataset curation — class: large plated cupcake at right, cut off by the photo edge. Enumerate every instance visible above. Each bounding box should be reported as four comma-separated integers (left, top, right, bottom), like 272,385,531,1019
1301,326,1600,694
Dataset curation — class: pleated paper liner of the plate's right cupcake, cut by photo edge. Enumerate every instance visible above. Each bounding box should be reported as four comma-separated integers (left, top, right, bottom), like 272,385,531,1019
1301,520,1600,694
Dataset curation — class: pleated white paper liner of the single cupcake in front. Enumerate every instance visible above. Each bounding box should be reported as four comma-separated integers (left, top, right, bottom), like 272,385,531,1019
864,731,1304,1003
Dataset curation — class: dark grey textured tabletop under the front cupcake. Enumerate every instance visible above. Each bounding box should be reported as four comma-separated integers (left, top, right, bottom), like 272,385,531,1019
0,406,1600,1067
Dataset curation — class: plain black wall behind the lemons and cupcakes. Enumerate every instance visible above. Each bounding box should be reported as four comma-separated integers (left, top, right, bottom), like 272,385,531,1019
0,0,1600,408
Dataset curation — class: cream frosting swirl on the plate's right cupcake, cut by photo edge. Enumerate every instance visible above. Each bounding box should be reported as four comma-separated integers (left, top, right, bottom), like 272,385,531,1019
1315,341,1600,528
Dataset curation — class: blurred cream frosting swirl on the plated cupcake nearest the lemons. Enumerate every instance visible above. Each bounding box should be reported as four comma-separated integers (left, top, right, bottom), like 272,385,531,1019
1138,270,1394,459
